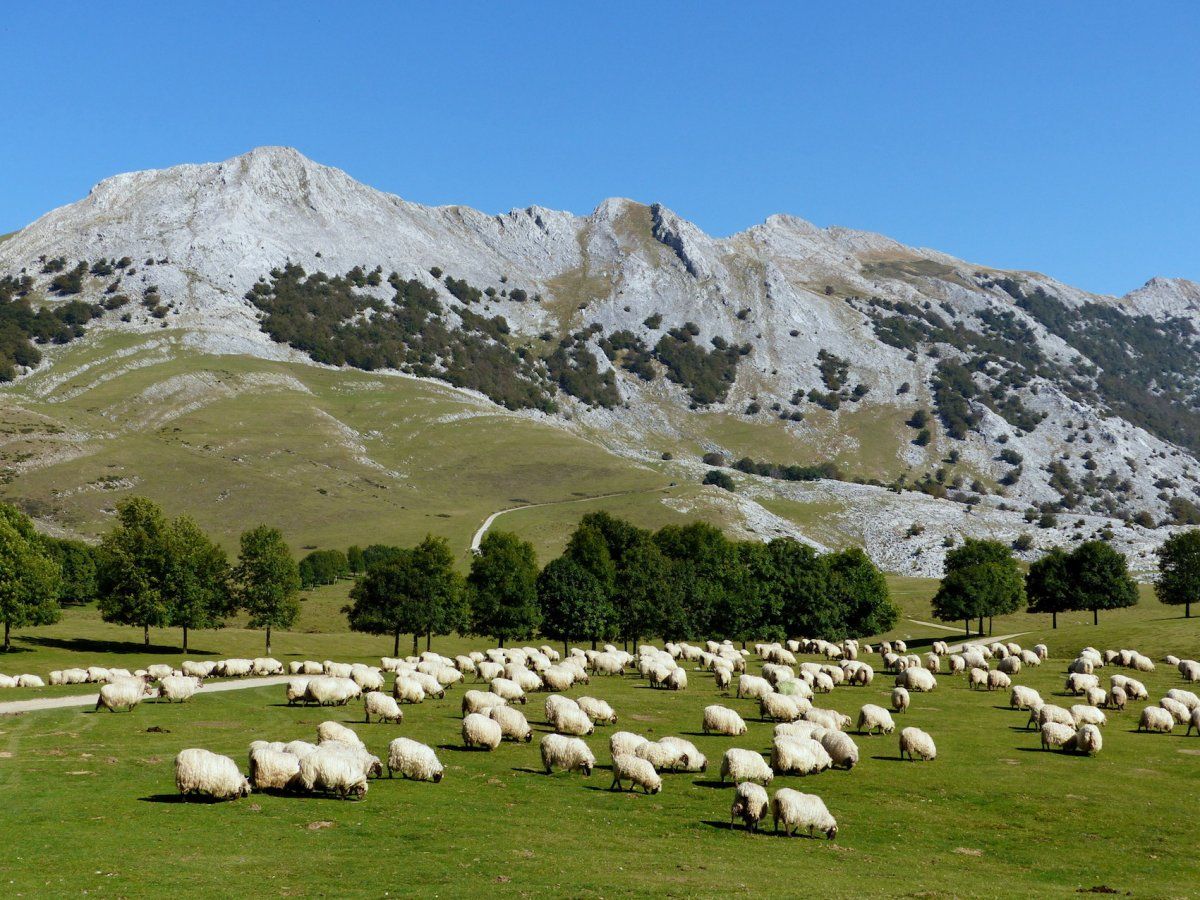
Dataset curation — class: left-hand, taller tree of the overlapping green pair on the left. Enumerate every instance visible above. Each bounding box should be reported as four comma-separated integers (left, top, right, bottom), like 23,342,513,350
100,497,173,647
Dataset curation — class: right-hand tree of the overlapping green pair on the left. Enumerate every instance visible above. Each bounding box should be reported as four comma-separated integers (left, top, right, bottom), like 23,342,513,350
164,516,233,653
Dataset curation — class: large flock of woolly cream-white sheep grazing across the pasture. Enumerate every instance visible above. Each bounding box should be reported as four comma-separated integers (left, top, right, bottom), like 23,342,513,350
18,640,1200,838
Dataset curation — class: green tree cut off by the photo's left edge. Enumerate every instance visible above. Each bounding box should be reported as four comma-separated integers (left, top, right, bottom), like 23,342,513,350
0,504,61,653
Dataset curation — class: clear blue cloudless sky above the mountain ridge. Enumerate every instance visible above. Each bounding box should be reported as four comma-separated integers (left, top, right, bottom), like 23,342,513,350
0,0,1200,293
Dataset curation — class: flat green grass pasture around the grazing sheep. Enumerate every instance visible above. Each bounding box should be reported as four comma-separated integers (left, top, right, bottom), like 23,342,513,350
0,578,1200,896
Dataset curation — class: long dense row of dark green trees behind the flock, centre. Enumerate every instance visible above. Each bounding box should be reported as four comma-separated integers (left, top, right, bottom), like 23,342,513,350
344,512,898,653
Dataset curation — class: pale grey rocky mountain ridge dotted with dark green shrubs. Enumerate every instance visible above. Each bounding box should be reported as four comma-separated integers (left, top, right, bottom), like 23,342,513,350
0,148,1200,572
